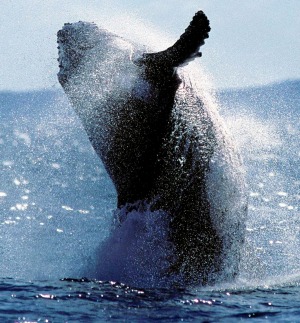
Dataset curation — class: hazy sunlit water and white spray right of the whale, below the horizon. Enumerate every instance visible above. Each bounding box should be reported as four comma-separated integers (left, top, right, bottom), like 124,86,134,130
220,81,300,284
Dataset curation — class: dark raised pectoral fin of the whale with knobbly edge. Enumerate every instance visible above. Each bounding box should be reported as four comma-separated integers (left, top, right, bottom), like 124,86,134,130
141,11,210,68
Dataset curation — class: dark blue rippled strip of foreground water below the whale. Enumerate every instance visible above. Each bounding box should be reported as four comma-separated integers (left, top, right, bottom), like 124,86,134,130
0,279,300,322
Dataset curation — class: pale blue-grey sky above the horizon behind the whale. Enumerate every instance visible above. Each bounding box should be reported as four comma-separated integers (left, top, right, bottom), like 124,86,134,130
0,0,300,91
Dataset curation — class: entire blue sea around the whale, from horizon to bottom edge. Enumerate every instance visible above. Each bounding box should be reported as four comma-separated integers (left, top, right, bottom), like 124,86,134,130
0,81,300,322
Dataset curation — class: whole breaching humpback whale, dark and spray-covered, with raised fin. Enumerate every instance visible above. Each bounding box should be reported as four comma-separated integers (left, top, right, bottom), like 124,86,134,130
58,11,247,284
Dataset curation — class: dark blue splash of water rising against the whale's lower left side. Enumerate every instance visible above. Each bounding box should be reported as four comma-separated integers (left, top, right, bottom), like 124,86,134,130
89,206,179,287
